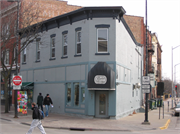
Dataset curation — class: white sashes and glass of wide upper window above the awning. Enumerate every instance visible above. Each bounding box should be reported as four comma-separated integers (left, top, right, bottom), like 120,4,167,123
97,28,108,53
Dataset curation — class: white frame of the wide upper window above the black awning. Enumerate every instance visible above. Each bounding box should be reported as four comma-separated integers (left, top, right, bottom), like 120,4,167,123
96,28,109,54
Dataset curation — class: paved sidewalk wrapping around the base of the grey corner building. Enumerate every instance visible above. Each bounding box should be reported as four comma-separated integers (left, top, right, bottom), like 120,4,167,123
0,100,172,131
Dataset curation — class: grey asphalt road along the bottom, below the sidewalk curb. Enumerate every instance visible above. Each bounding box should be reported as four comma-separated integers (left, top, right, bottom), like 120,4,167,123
0,117,180,134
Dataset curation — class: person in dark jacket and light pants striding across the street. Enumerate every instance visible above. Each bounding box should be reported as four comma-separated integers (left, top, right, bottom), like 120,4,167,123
26,102,46,134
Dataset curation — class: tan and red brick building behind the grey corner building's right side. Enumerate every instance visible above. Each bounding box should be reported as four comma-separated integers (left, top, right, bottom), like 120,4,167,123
124,15,157,103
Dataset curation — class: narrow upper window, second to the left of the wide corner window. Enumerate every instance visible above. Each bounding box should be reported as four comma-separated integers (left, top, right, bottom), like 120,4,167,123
62,31,68,57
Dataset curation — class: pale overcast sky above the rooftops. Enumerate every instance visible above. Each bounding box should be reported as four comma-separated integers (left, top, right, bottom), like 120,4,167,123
66,0,180,82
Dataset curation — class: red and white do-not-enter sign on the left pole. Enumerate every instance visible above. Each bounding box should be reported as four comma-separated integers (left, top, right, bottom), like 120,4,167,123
13,75,22,90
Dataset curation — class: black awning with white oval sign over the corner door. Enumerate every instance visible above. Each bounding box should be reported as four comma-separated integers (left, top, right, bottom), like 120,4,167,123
88,62,115,90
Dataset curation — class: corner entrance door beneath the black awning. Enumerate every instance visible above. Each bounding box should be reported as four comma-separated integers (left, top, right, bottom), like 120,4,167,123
95,91,108,118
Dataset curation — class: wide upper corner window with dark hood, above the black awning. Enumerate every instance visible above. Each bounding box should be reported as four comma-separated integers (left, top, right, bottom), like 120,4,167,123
95,24,110,53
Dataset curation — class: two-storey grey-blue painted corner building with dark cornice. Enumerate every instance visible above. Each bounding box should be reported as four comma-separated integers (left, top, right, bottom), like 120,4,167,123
20,7,142,119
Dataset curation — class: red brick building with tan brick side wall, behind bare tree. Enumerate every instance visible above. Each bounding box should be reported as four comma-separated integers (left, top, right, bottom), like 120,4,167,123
0,0,81,107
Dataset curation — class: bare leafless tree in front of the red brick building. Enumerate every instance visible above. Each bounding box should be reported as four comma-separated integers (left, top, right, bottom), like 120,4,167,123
1,0,42,113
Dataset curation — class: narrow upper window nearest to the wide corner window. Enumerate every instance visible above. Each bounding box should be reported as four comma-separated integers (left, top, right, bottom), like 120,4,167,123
75,27,81,55
